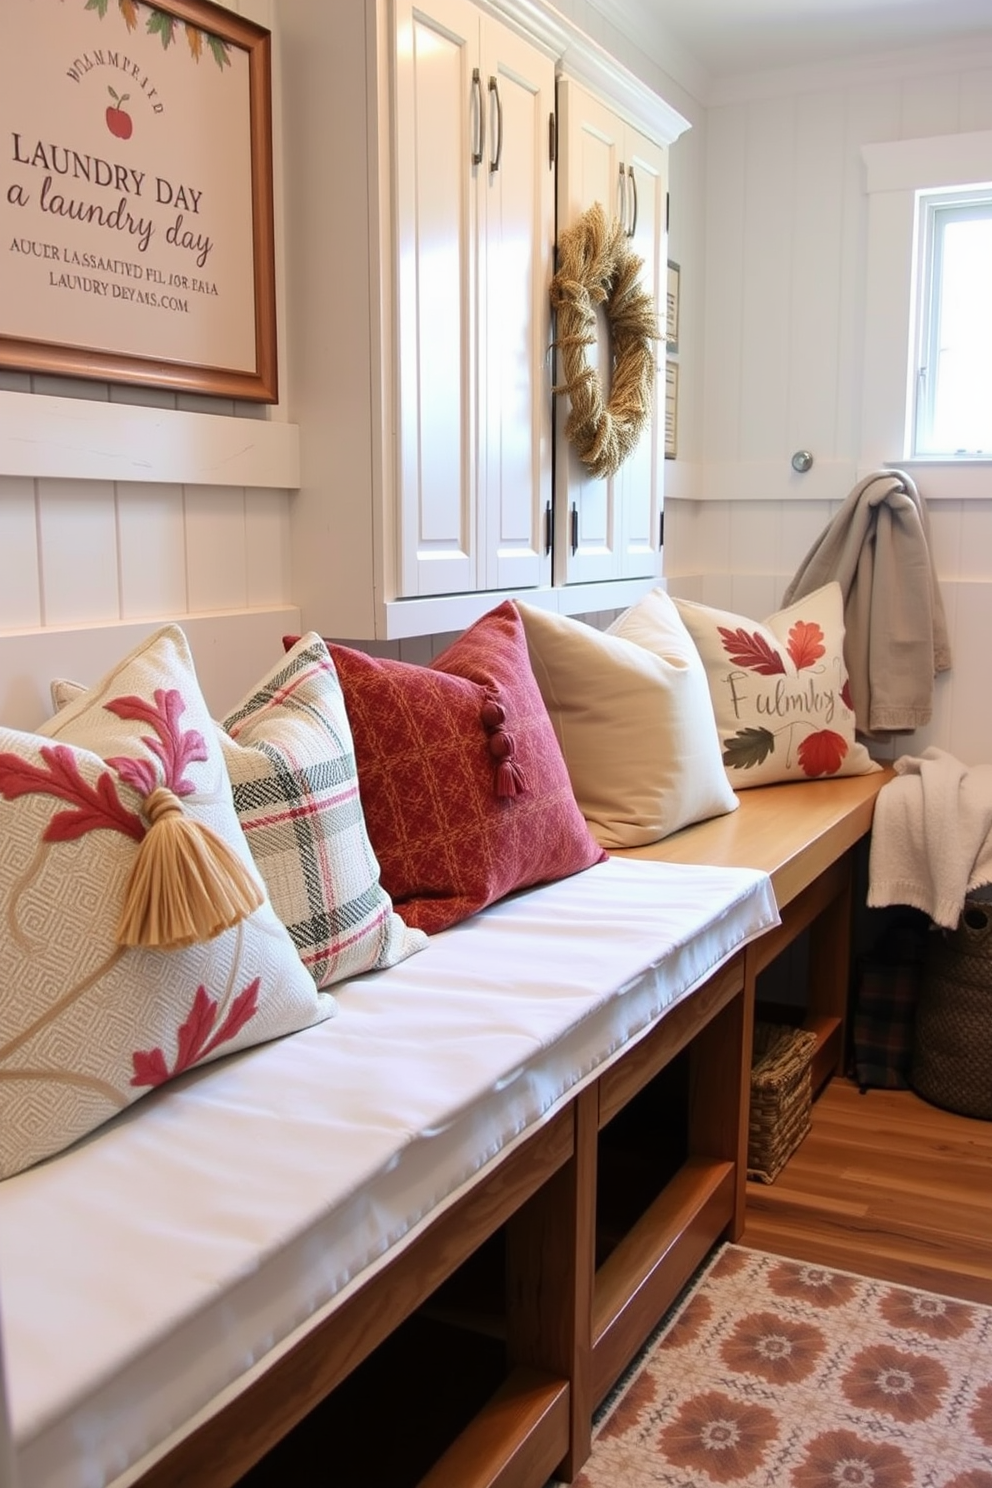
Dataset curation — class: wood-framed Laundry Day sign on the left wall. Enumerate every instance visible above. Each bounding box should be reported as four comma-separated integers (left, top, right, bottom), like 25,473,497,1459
0,0,278,403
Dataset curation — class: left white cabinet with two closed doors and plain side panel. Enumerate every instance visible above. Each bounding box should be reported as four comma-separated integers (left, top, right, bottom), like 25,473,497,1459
280,0,555,638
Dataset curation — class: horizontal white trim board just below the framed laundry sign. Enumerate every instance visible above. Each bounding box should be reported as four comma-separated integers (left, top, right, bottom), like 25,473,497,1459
0,390,299,490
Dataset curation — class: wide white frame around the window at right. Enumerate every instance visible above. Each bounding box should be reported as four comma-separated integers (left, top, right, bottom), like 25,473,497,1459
858,129,992,498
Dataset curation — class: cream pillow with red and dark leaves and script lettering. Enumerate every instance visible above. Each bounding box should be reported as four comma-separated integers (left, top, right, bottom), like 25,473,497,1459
675,583,880,790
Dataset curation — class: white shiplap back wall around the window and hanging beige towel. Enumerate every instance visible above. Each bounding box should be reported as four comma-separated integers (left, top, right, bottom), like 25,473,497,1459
665,43,992,763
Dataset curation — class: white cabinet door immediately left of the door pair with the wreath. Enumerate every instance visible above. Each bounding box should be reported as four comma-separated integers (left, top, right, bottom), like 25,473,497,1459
479,19,555,589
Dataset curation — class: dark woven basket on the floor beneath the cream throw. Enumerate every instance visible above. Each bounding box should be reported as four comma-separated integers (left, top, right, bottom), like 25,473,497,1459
910,899,992,1120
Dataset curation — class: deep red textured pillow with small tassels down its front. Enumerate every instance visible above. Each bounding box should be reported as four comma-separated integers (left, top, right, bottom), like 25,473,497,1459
322,601,607,934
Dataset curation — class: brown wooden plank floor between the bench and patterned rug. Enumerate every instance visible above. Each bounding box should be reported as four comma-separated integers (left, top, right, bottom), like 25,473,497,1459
741,1077,992,1305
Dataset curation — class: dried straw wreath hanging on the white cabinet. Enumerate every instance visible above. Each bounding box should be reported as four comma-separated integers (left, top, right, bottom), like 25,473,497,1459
550,202,660,478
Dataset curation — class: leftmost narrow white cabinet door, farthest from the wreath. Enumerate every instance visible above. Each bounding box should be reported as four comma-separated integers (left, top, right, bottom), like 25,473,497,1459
392,0,483,597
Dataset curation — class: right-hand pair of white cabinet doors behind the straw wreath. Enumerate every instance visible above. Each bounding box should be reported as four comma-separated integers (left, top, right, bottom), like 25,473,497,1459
555,77,668,583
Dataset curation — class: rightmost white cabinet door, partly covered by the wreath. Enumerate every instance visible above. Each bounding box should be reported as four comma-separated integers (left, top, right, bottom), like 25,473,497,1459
616,126,668,579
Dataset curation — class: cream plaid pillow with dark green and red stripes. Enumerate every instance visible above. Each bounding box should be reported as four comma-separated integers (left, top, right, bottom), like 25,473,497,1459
220,634,427,987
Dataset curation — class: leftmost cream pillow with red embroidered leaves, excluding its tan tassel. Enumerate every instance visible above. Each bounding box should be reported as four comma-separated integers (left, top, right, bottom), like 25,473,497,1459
0,625,336,1178
